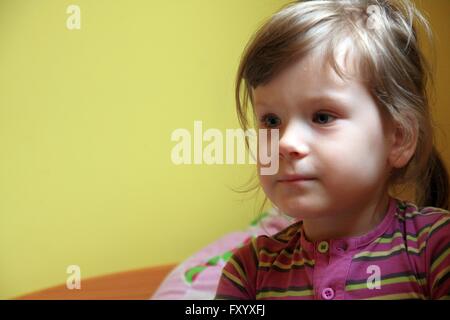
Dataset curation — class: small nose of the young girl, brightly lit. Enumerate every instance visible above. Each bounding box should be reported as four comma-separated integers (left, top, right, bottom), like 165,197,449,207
279,124,309,160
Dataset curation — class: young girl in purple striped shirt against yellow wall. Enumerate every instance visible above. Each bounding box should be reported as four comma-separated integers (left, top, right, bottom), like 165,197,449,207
216,0,450,300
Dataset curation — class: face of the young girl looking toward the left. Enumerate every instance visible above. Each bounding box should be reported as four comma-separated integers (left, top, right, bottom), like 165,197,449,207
253,52,391,218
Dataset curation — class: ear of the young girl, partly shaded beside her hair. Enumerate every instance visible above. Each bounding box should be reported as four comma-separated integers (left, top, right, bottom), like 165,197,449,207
388,117,418,169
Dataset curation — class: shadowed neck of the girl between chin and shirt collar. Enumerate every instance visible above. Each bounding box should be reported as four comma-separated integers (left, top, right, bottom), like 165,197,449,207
303,193,389,242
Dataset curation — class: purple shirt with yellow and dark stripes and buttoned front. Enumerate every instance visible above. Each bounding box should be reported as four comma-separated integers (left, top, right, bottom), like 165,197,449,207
216,197,450,300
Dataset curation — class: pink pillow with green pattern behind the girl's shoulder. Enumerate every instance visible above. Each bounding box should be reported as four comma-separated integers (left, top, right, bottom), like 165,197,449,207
150,209,295,300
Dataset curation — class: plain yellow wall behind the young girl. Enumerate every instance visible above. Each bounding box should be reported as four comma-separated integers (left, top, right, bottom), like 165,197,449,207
0,0,450,299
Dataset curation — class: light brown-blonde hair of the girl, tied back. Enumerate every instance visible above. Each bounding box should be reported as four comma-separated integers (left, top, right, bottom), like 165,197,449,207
235,0,448,209
